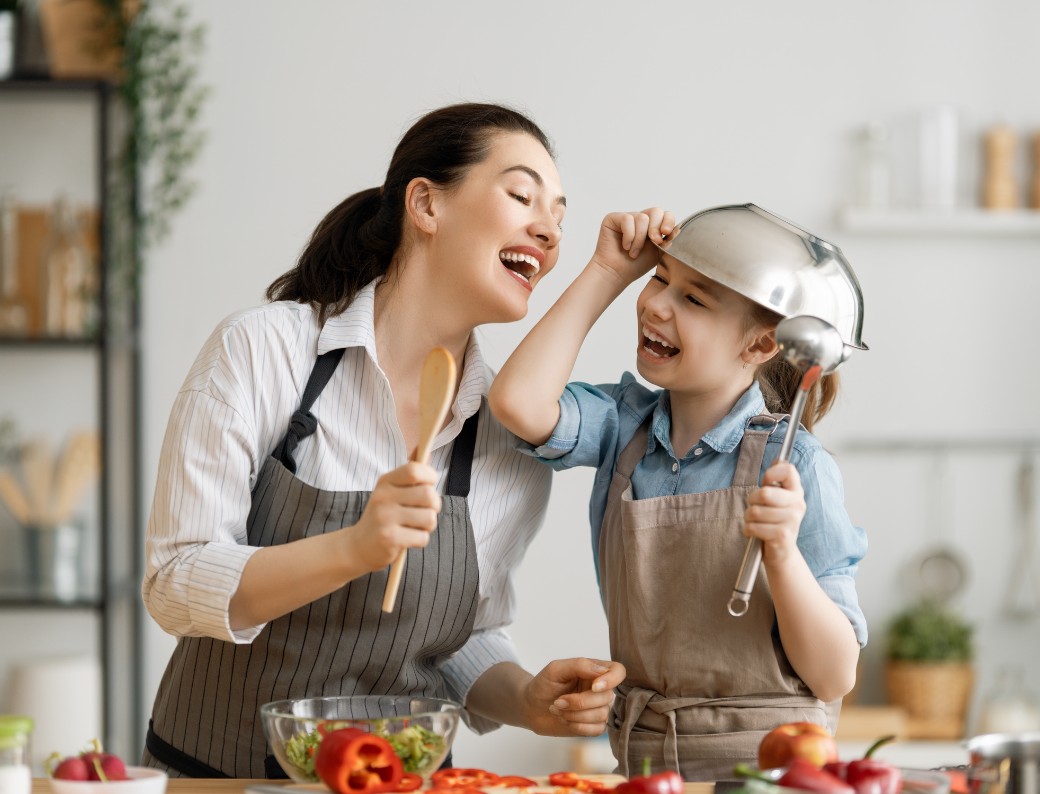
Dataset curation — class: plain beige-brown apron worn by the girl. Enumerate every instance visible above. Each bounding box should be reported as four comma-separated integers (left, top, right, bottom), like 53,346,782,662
599,415,840,780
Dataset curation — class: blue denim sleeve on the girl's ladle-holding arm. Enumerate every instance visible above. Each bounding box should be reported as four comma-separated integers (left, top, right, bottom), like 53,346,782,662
791,446,867,647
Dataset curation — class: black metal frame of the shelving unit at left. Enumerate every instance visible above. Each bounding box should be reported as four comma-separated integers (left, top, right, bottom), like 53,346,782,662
0,78,144,758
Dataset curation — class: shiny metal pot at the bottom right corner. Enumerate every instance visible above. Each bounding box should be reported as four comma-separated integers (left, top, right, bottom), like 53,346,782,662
968,732,1040,794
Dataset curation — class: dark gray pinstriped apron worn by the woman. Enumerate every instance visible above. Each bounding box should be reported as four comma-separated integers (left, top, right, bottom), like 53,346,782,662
142,350,478,777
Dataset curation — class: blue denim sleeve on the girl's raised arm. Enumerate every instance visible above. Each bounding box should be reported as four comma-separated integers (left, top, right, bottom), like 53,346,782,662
517,383,618,470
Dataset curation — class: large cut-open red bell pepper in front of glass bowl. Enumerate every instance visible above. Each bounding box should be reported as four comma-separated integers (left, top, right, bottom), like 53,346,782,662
314,727,405,794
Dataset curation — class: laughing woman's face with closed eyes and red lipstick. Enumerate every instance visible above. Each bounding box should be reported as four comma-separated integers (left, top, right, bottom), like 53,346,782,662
430,132,567,325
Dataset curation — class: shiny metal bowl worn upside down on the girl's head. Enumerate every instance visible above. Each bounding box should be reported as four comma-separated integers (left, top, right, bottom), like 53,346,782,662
661,204,867,350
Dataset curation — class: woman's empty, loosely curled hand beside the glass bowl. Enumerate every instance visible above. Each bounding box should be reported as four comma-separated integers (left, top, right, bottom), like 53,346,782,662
524,658,625,736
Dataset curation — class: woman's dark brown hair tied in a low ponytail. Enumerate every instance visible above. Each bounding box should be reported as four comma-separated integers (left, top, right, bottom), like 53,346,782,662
266,103,552,324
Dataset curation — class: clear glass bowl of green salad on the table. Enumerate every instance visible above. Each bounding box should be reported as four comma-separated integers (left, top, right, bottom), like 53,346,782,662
260,695,462,783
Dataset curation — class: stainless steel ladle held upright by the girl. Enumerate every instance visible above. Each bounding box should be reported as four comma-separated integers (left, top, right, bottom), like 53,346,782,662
727,316,847,617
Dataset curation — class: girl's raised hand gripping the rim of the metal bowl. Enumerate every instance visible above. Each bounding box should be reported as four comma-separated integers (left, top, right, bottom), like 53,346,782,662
592,207,675,286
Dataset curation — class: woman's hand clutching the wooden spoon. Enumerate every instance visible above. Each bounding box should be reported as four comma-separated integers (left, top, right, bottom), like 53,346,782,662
341,461,441,572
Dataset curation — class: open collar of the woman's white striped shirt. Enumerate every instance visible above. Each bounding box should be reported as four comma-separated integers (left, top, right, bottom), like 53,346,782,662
317,277,492,421
